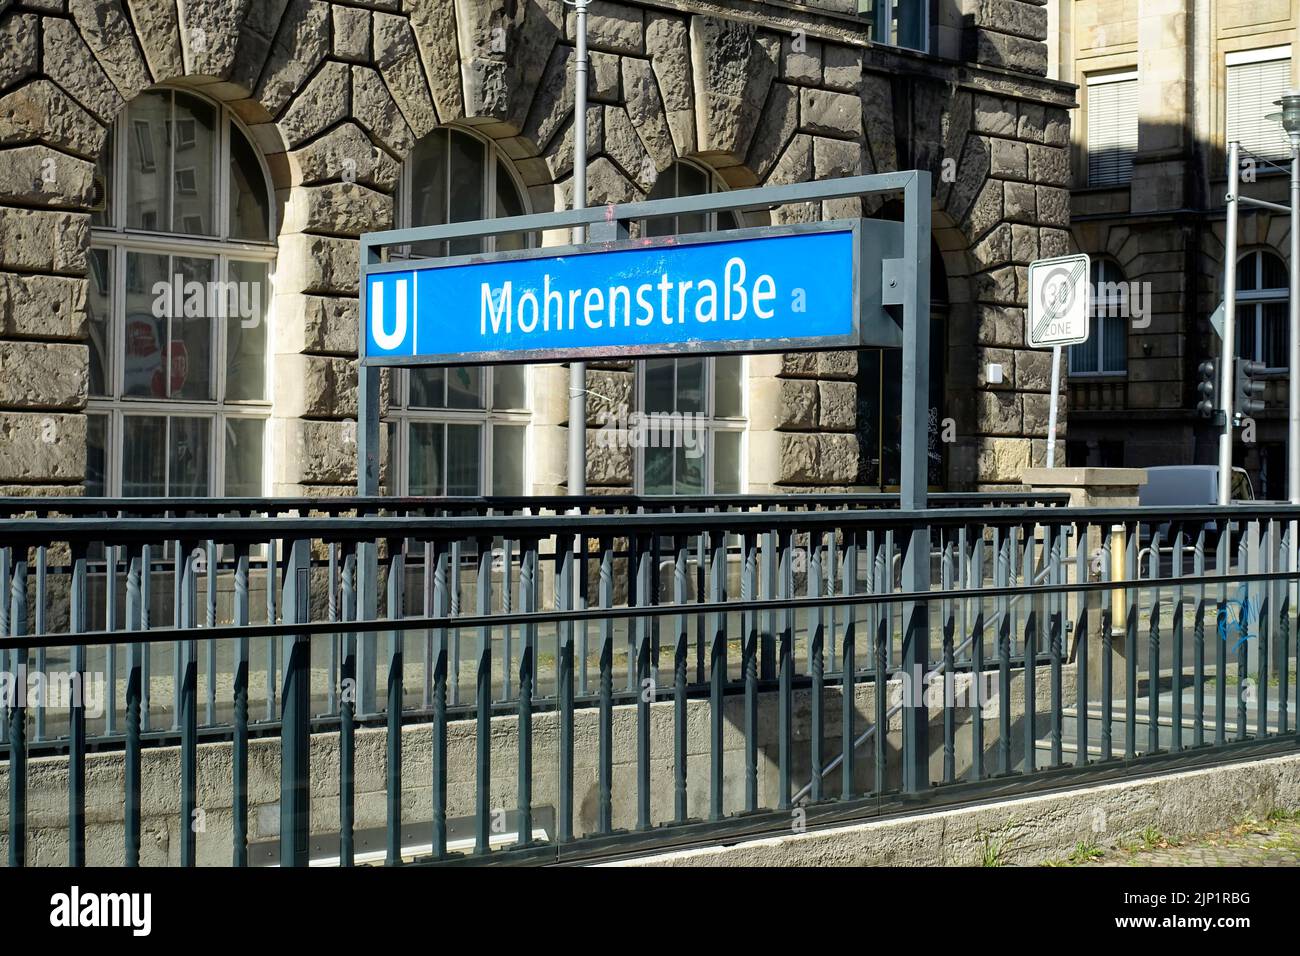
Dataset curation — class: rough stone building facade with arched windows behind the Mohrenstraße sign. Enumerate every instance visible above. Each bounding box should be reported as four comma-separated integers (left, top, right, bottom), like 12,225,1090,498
0,0,1075,504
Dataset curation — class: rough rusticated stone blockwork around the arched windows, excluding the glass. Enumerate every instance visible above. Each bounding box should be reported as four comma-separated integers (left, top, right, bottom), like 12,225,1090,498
0,0,1074,493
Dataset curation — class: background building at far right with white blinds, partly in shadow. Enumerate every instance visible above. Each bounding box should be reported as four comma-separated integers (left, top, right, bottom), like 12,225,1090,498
1053,0,1300,499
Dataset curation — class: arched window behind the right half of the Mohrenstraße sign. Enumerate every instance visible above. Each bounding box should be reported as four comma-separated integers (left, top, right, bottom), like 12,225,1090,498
636,161,745,494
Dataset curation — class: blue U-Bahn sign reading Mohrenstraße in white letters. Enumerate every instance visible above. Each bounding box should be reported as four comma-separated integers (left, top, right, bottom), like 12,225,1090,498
363,220,902,365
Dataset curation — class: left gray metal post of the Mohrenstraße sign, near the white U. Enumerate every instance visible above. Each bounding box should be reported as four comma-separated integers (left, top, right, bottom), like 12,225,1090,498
354,241,379,714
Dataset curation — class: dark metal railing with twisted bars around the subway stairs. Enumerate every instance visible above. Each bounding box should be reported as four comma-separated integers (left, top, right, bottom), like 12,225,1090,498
0,496,1300,865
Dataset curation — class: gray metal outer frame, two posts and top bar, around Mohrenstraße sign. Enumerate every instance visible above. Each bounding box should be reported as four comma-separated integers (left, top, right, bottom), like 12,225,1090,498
356,169,932,792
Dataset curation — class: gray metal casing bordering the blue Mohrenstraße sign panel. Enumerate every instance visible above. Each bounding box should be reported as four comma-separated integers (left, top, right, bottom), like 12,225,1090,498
360,219,902,368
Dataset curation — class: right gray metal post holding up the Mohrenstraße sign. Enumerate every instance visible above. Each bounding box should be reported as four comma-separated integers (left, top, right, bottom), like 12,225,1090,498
899,172,931,793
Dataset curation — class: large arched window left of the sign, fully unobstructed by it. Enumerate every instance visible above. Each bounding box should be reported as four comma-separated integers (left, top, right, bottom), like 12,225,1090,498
86,88,276,497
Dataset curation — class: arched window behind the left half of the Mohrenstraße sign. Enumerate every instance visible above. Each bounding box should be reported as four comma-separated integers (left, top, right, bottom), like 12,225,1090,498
389,129,530,496
